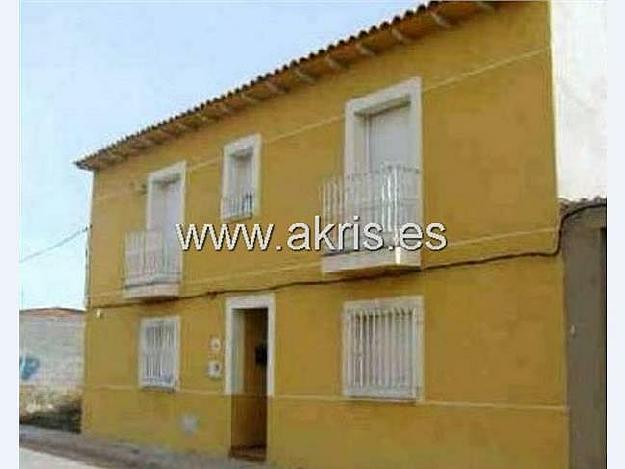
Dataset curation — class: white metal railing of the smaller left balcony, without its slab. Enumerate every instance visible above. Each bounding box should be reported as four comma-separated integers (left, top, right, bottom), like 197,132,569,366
124,230,181,288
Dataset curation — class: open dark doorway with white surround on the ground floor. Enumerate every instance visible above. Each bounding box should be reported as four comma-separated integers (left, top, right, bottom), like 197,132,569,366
226,297,273,461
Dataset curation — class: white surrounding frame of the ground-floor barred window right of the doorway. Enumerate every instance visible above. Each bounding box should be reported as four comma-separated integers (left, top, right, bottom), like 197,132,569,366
342,296,424,401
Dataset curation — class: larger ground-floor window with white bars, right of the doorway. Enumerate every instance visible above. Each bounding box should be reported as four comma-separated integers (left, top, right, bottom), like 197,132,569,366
343,297,423,399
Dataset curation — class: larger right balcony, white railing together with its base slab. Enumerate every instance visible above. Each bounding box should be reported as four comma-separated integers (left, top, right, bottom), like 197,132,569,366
321,165,421,273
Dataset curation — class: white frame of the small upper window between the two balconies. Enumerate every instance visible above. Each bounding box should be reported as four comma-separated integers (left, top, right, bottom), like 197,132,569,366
221,134,262,221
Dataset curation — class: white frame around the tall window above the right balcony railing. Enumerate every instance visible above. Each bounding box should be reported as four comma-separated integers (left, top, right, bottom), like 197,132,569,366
345,77,422,176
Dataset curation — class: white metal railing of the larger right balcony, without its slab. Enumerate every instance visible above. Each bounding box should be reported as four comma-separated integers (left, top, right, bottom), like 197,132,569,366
321,165,420,254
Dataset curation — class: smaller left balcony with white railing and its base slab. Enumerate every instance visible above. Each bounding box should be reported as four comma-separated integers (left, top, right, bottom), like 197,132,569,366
124,230,182,299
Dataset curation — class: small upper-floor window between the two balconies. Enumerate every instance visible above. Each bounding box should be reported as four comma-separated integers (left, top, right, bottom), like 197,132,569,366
221,134,260,220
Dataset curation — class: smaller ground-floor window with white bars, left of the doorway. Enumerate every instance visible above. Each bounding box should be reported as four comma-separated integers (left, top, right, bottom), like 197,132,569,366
139,316,180,389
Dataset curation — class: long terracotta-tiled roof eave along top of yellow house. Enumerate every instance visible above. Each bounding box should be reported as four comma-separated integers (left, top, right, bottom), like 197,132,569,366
75,1,497,171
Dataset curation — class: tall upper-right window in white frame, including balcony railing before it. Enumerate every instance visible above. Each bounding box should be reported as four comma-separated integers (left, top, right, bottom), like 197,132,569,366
323,78,422,255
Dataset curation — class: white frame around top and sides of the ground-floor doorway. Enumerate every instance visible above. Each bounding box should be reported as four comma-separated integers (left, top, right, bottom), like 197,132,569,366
224,293,276,397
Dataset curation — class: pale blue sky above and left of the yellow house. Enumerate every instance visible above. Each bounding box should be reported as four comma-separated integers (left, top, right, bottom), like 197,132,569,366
19,0,417,308
